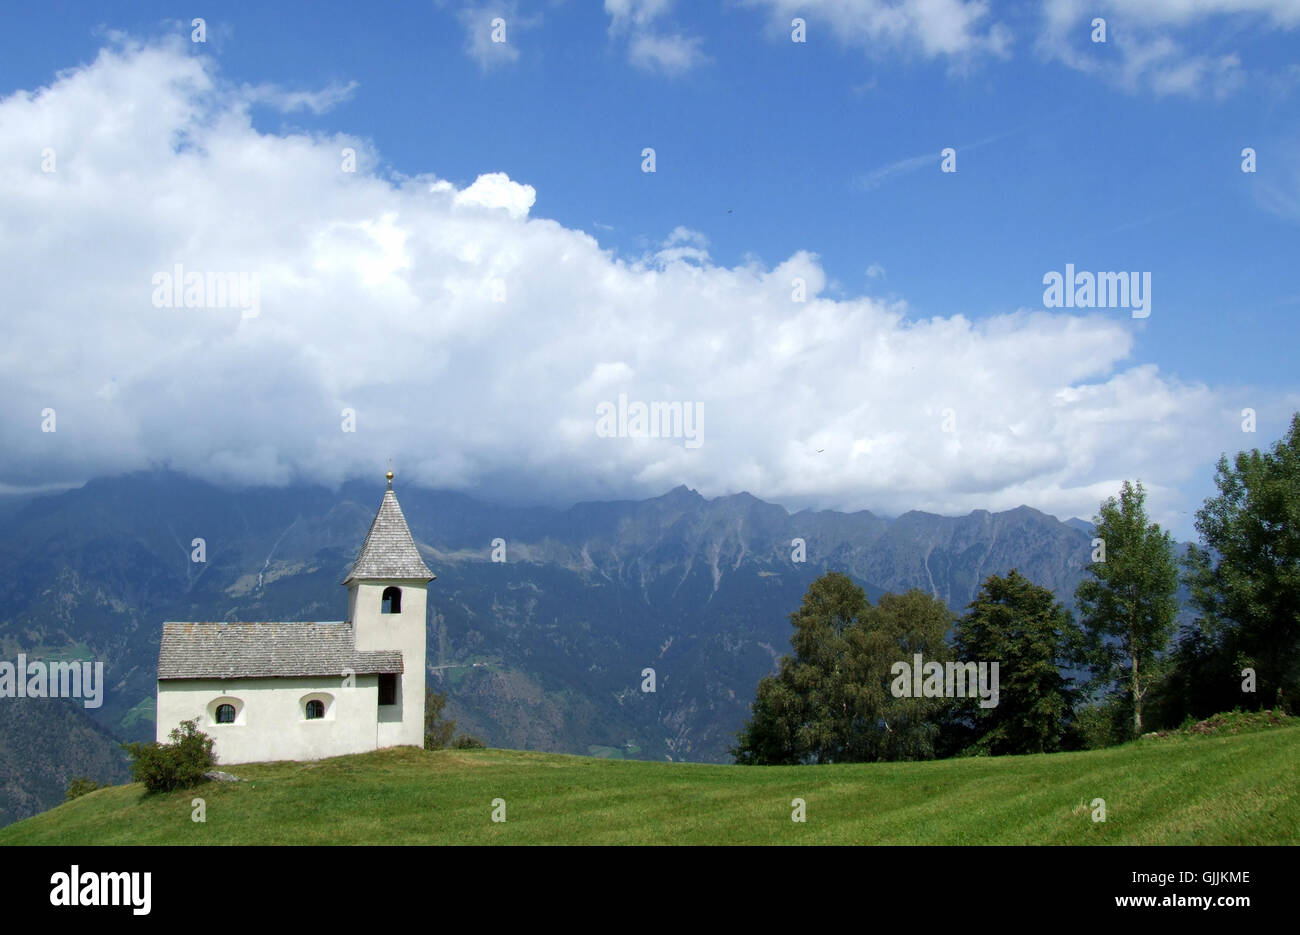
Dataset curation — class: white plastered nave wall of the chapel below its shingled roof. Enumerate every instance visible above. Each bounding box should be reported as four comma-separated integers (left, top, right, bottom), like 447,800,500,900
157,675,382,766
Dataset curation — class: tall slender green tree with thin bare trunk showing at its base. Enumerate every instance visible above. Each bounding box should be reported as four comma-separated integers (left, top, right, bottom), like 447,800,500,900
1075,481,1178,735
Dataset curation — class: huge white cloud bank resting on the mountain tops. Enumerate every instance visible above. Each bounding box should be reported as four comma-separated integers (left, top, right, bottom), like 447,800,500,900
0,42,1296,533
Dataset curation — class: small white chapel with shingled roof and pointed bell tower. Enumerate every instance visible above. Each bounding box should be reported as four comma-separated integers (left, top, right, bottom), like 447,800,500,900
157,471,434,763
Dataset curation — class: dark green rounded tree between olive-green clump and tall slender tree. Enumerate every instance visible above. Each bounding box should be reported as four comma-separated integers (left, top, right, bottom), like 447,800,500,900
956,568,1083,756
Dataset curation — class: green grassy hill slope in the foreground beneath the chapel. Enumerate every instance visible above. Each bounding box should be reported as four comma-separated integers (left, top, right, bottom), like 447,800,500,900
0,726,1300,844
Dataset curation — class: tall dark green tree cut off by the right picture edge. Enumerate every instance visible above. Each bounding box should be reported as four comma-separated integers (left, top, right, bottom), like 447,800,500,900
1186,412,1300,709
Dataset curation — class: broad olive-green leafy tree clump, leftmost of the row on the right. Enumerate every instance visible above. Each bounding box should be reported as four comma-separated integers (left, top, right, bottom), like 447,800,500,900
732,572,952,763
